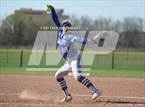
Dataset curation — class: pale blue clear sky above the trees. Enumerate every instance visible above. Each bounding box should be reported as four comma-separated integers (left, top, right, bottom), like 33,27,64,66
0,0,145,20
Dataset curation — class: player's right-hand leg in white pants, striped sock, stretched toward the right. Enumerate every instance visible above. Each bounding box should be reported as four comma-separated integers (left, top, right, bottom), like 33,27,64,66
71,60,101,99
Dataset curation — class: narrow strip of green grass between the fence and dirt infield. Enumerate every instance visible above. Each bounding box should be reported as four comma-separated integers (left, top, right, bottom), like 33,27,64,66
0,67,145,78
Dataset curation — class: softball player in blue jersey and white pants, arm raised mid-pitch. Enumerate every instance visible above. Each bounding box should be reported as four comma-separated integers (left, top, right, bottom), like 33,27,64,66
47,5,101,102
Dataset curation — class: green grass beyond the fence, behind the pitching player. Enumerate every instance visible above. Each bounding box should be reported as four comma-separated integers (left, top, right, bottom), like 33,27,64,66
0,49,145,70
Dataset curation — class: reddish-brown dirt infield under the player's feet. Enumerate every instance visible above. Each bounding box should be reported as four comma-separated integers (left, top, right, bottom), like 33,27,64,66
0,75,145,107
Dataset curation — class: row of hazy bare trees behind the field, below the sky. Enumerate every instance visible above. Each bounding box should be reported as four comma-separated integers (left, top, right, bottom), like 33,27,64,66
0,10,145,49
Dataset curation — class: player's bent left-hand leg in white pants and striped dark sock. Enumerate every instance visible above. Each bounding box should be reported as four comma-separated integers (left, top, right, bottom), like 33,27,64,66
55,63,71,101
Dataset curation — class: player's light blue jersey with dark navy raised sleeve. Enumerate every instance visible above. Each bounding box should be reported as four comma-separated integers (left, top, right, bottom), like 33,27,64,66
51,9,88,60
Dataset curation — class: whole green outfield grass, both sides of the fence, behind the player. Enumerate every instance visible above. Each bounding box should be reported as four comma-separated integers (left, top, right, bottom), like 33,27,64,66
0,49,145,77
